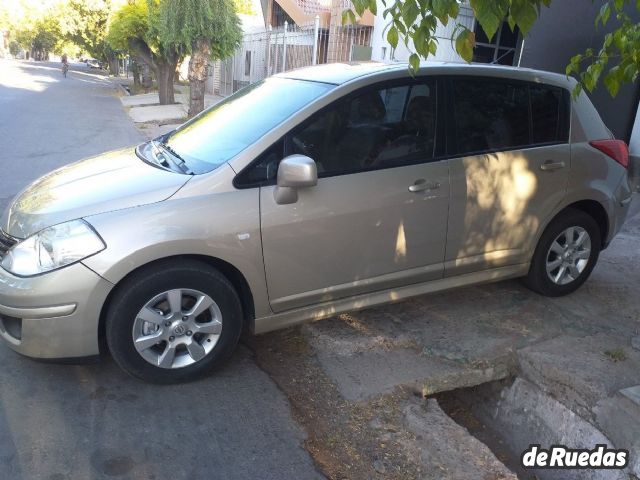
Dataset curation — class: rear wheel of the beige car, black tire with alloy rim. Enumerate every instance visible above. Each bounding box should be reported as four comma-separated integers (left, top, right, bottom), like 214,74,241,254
523,209,602,297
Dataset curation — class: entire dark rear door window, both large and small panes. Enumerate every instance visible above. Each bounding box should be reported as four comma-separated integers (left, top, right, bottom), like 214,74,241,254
449,77,569,154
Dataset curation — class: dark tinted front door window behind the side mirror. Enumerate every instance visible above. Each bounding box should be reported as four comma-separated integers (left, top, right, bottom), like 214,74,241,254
288,81,437,176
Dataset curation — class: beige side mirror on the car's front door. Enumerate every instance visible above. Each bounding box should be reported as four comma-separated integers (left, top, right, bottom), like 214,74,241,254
273,155,318,205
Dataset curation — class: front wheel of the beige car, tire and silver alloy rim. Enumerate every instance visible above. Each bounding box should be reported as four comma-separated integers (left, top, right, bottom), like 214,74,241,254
105,260,243,384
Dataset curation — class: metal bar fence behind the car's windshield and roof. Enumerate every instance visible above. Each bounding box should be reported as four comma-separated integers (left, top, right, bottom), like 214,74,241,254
211,17,372,96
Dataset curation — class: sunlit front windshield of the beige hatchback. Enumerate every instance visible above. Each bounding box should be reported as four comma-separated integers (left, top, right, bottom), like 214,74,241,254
163,78,334,174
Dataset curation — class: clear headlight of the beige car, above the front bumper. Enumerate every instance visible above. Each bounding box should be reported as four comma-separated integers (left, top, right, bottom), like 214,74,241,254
2,220,106,277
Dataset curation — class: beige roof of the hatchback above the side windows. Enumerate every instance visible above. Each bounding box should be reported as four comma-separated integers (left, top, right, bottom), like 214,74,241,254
276,61,574,87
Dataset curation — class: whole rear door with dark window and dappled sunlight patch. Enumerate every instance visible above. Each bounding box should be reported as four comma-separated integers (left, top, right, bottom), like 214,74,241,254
445,76,571,276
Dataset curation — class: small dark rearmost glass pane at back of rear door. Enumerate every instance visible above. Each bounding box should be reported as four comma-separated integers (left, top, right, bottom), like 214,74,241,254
529,85,569,143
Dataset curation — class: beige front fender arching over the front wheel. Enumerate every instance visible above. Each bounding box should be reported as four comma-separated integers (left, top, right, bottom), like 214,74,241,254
83,189,272,316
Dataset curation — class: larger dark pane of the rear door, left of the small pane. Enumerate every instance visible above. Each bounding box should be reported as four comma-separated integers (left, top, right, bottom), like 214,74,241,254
452,78,531,154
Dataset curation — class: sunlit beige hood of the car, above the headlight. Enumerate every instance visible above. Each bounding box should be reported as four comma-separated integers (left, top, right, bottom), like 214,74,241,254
0,148,191,238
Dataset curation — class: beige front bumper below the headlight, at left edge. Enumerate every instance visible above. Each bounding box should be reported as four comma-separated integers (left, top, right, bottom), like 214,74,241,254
0,263,113,359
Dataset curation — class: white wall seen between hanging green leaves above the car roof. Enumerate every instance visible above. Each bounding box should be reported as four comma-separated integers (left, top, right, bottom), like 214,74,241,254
371,0,474,62
